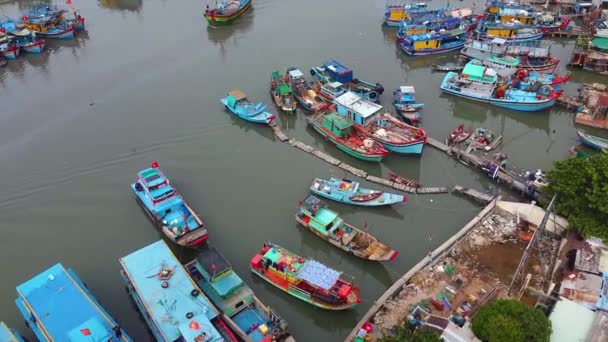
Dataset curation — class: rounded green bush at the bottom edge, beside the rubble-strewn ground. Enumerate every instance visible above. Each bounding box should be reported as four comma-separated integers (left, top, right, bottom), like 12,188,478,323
473,299,551,342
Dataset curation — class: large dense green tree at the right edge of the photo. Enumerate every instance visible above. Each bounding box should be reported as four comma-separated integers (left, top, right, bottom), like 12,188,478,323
547,153,608,241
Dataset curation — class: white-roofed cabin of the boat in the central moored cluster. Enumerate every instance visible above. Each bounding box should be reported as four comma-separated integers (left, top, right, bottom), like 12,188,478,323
334,91,382,126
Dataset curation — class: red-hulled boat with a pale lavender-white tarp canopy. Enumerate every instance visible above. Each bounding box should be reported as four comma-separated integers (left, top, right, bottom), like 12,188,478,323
250,242,361,310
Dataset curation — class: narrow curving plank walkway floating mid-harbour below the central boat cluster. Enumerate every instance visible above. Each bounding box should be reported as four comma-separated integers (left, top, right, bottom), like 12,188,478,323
270,121,449,194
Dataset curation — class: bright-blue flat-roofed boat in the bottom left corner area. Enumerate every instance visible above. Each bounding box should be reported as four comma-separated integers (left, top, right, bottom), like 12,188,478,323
15,263,132,342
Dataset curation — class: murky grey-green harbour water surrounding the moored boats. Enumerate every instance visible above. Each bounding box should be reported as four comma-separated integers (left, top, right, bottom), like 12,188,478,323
0,0,603,341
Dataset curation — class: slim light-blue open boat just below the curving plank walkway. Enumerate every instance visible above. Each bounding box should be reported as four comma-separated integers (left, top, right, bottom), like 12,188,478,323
310,177,407,207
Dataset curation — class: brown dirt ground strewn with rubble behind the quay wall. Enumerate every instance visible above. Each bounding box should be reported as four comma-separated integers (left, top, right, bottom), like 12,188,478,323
372,209,556,336
